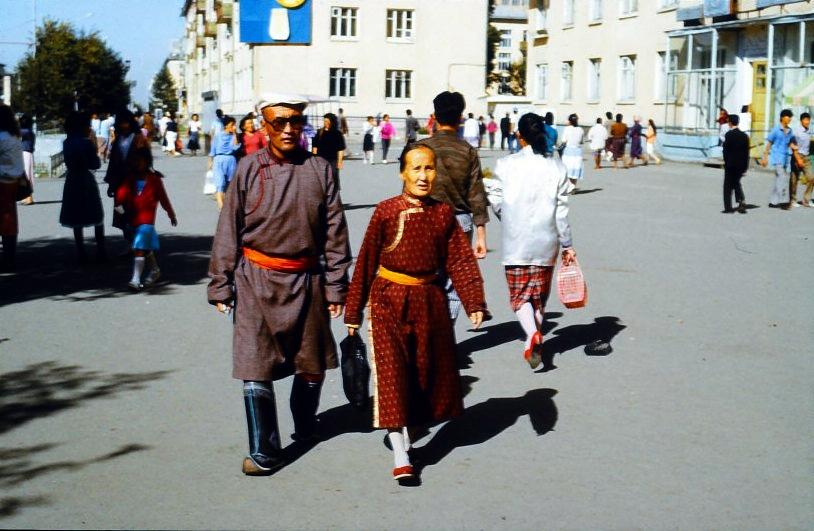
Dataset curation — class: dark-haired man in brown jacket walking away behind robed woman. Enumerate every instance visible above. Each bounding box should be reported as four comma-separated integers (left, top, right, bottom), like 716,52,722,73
419,91,489,320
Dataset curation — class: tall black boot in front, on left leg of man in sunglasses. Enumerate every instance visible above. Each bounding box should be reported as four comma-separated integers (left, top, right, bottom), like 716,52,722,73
243,382,285,476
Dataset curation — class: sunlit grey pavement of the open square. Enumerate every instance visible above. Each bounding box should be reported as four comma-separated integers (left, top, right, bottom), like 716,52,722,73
0,143,814,530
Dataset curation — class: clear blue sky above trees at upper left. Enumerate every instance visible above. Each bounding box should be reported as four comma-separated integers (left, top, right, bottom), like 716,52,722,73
0,0,184,104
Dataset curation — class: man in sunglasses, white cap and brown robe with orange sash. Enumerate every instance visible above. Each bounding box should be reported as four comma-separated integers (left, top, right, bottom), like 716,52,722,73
208,98,351,475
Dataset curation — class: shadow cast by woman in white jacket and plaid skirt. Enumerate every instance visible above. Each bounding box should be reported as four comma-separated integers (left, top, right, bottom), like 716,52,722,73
537,315,627,372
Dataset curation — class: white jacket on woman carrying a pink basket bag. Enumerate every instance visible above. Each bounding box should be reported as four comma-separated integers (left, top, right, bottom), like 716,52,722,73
484,146,571,266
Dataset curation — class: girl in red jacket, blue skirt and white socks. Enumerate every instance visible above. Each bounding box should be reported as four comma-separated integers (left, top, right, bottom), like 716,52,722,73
115,146,178,291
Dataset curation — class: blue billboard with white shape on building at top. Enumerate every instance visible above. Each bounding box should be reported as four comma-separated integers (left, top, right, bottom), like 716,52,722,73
240,0,313,44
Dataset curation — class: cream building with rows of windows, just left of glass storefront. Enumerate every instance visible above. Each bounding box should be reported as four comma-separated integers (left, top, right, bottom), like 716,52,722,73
526,0,683,125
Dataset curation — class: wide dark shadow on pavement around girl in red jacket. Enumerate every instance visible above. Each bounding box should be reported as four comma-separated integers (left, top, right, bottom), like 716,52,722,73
0,233,212,306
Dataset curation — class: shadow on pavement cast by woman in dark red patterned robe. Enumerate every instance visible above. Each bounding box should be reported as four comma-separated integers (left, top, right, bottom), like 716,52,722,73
413,389,557,472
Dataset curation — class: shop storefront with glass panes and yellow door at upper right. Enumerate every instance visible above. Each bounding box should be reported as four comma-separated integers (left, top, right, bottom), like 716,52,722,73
664,13,814,158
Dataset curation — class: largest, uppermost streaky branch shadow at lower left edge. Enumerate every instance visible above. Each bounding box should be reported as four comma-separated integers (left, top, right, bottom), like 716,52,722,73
0,361,172,434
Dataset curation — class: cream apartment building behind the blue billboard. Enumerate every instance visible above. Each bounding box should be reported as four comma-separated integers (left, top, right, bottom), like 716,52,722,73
182,0,489,129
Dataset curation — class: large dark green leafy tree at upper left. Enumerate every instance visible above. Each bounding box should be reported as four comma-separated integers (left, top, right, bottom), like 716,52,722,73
14,20,130,127
